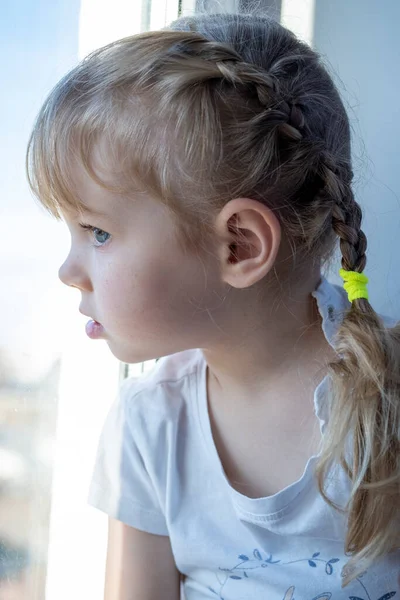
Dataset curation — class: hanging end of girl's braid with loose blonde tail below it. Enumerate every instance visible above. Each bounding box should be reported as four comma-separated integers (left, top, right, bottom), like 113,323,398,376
316,172,400,586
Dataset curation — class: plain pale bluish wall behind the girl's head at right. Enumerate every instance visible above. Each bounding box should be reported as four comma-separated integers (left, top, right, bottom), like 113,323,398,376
314,0,400,318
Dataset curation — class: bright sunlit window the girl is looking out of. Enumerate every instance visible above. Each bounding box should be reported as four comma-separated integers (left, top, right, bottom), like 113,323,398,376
0,0,190,600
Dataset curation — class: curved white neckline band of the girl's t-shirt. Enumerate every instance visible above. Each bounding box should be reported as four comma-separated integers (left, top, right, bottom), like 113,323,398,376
196,276,350,523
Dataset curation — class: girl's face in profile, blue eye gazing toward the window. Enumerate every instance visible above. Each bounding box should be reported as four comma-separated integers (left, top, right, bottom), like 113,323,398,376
59,159,222,363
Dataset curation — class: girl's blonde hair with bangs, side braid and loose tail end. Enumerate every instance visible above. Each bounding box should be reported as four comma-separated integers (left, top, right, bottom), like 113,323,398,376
27,8,400,585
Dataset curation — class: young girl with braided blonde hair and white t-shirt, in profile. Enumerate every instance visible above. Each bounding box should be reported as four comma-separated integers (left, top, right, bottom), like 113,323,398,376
28,9,400,600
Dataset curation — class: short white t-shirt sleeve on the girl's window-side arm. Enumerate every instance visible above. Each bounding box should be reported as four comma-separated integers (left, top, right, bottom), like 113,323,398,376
88,378,168,535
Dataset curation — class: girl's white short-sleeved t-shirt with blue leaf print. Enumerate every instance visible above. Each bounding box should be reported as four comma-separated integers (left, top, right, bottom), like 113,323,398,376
89,278,400,600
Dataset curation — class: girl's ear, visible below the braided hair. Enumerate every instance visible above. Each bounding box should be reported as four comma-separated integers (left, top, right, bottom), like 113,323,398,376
215,198,281,288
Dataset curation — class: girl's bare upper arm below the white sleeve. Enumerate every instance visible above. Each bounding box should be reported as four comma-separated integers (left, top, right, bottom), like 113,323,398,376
104,517,180,600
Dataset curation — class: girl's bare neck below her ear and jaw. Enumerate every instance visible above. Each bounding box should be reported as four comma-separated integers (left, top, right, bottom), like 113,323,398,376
203,277,334,405
